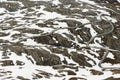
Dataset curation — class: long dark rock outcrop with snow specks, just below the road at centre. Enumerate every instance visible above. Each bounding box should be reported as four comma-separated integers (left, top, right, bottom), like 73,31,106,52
34,34,72,47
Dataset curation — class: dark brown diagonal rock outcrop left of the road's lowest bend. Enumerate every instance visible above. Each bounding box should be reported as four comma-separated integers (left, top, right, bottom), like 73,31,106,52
70,52,92,67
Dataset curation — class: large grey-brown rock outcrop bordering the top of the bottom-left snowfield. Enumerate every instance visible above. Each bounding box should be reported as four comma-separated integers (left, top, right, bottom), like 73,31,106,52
27,49,61,66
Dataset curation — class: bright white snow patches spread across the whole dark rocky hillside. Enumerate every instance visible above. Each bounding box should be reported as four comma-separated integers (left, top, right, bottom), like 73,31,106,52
0,0,120,80
